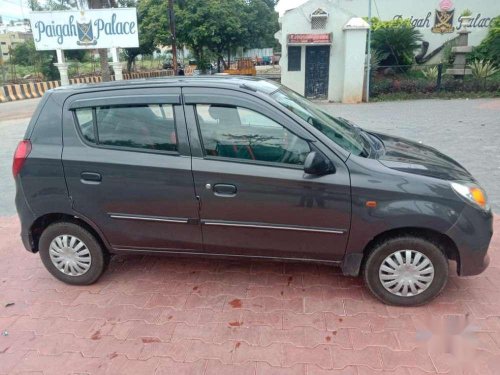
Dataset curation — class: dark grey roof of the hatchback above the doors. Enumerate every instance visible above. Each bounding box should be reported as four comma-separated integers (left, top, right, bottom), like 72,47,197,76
50,75,280,95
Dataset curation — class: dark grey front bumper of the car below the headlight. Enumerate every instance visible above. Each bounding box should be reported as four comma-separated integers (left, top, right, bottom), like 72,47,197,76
446,204,493,276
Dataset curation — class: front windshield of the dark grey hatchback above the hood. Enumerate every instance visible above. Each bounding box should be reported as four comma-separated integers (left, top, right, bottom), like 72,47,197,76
271,87,369,157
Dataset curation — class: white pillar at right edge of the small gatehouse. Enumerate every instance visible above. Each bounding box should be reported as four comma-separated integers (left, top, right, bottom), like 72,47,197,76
342,18,370,103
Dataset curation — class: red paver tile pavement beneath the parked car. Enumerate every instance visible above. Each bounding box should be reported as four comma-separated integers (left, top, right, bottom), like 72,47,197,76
0,217,500,375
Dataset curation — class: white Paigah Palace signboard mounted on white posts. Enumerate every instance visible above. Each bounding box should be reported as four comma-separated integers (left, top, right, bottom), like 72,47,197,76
30,8,139,51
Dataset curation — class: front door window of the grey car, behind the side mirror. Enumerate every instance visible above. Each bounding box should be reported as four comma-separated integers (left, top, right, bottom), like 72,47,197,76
196,104,310,165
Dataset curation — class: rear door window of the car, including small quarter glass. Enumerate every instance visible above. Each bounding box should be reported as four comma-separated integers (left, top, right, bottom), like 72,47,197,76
76,104,177,151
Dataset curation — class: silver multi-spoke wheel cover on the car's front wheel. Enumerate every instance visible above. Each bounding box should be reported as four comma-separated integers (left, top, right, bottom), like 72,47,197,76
379,250,434,297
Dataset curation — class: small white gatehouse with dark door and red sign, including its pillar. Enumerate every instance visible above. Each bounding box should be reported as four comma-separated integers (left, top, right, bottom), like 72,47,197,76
275,0,369,103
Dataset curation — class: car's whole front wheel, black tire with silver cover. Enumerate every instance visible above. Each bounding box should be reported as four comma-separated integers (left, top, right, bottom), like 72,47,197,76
363,236,448,306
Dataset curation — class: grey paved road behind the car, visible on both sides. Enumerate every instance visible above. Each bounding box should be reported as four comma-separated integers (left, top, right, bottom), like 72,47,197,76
0,99,500,216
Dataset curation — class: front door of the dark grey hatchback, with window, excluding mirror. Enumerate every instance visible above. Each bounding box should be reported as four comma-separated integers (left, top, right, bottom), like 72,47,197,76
183,87,351,261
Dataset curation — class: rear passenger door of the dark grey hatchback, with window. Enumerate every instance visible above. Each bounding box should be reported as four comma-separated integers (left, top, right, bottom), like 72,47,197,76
62,88,201,251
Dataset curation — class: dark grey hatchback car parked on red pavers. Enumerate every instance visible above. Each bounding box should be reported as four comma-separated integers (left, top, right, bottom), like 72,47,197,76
13,77,493,305
